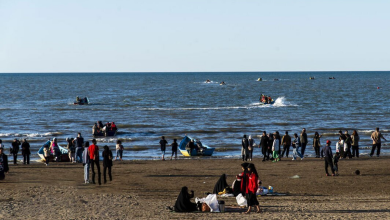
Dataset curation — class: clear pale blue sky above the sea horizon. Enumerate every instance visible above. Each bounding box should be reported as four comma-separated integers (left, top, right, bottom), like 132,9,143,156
0,0,390,73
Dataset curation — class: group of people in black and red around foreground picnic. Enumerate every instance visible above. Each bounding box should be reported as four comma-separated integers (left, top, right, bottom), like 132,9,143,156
170,163,261,214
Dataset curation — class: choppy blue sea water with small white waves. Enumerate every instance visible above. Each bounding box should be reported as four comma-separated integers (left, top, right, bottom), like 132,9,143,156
0,72,390,159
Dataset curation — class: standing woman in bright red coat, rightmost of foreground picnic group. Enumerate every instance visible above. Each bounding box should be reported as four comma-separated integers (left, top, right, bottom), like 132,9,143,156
245,164,260,214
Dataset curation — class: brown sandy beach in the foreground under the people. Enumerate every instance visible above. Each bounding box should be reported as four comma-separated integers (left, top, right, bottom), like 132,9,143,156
0,157,390,219
